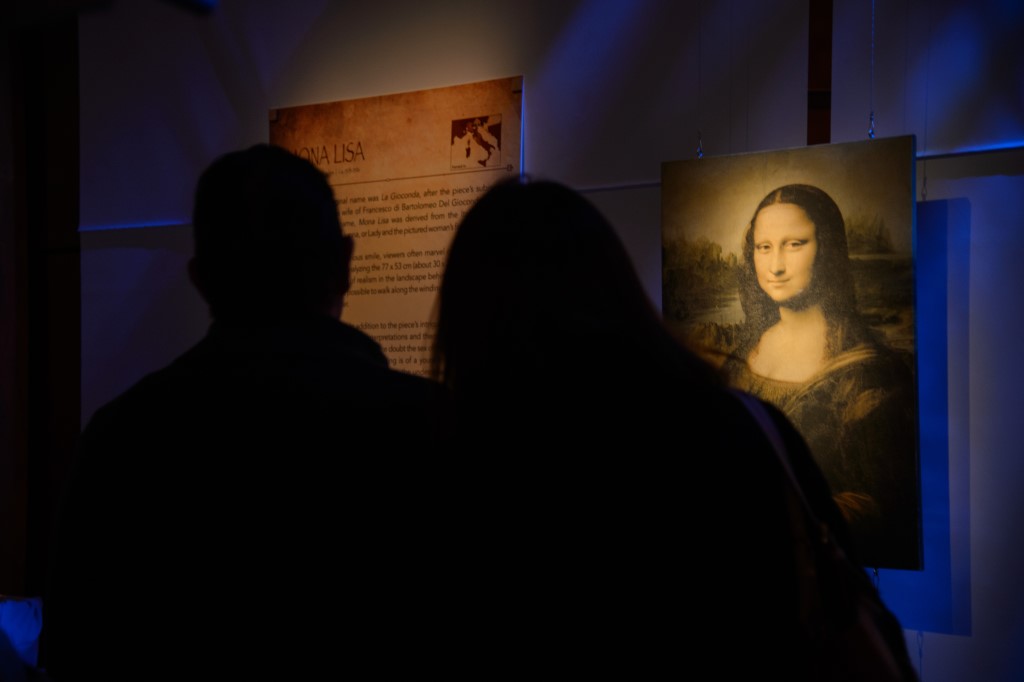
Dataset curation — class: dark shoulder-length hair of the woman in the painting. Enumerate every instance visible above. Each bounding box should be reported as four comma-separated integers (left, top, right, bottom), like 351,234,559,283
738,184,870,357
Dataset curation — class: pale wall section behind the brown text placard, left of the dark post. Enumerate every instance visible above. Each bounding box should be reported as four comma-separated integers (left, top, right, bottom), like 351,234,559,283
80,0,808,420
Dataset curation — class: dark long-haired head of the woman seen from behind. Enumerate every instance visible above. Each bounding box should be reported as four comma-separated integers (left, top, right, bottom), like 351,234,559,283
431,178,707,397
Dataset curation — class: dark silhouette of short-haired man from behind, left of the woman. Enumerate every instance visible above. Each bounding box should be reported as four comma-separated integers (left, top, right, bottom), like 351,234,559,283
42,144,449,682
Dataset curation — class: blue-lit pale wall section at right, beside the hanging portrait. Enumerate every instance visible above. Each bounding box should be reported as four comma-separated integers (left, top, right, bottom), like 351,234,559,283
831,0,1024,680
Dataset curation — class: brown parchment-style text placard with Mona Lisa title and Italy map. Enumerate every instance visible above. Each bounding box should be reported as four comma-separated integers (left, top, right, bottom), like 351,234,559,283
270,76,522,376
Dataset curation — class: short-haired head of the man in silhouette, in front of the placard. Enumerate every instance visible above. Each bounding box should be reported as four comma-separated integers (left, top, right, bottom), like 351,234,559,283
189,144,352,322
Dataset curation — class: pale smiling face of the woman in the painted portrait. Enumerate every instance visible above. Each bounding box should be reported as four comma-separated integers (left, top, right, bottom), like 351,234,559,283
754,204,818,305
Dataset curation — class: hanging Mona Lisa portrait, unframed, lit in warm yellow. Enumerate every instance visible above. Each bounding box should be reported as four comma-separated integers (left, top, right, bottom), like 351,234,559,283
662,136,922,569
